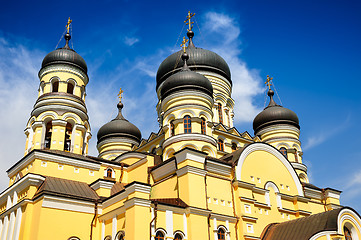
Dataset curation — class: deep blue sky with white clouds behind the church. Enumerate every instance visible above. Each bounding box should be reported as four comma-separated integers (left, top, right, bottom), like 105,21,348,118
0,0,361,212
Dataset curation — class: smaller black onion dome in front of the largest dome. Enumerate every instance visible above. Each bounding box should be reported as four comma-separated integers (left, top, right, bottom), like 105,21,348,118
160,53,213,100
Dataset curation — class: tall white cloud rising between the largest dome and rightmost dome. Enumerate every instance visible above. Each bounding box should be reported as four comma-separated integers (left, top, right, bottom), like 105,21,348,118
202,12,263,123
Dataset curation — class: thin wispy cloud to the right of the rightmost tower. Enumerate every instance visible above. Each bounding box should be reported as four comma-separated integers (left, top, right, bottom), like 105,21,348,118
302,115,350,151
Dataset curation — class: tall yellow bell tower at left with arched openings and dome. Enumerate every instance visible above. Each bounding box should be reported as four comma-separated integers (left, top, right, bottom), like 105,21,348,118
25,18,91,155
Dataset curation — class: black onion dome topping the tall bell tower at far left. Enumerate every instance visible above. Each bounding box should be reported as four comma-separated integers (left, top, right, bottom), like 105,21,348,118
41,33,88,73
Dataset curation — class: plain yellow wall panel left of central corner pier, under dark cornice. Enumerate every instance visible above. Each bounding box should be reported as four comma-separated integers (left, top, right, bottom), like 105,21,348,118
150,176,178,199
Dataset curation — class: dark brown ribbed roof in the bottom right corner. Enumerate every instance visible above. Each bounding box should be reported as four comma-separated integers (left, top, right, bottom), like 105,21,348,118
261,208,343,240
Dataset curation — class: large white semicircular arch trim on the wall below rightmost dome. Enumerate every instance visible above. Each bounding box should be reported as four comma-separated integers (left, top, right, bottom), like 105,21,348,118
236,143,304,196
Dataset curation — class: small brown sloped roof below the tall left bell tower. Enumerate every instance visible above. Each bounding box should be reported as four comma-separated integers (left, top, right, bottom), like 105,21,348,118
34,176,99,201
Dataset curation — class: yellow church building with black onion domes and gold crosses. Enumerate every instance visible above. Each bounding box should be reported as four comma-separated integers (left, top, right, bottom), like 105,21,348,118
0,13,361,240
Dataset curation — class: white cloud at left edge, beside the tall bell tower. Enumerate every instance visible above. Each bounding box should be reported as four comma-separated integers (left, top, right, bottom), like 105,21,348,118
0,37,44,189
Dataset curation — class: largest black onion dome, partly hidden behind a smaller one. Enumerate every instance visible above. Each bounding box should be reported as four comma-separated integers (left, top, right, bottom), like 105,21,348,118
157,32,232,90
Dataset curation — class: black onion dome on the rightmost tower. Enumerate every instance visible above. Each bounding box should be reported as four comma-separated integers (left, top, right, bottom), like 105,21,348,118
253,90,300,133
